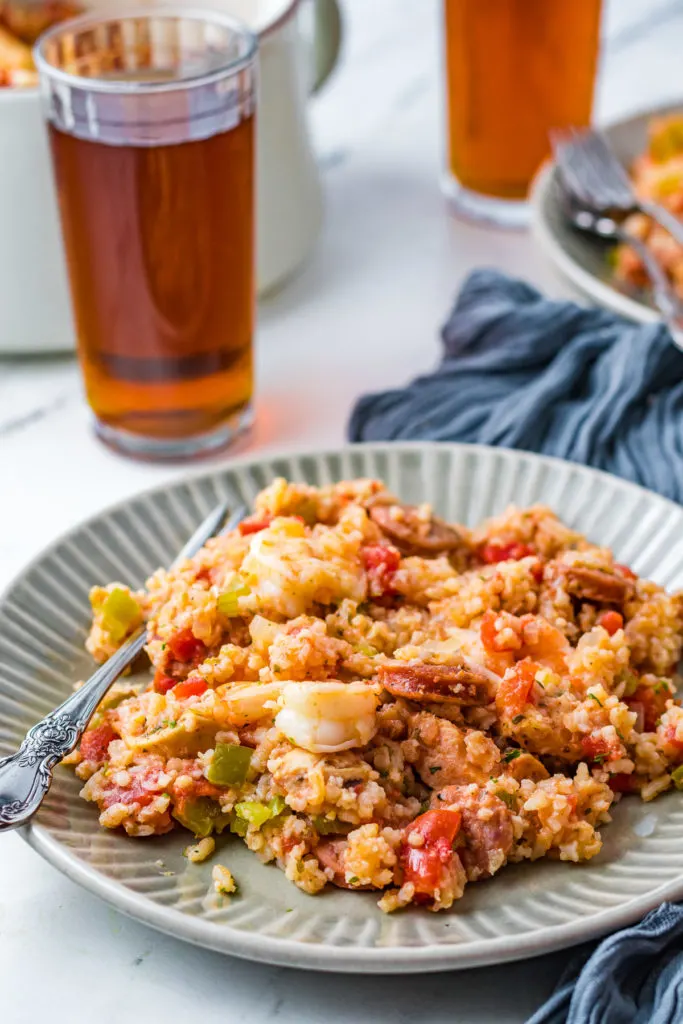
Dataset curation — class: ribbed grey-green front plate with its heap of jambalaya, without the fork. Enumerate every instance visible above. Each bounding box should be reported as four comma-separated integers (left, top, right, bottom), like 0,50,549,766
0,444,683,973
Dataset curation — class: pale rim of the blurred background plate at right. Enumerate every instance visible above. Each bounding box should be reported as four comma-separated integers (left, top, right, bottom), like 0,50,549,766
529,99,683,324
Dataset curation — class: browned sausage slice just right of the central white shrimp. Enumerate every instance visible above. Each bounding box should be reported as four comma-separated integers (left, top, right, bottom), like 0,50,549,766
378,662,494,706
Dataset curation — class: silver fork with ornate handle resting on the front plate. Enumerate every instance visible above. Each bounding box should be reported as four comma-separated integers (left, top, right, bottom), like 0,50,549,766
0,503,247,831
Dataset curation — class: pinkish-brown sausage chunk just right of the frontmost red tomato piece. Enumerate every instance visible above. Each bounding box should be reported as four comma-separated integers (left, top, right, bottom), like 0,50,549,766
432,785,514,882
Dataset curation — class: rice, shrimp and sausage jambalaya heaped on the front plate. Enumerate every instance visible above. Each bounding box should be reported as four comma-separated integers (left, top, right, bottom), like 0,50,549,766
68,479,683,911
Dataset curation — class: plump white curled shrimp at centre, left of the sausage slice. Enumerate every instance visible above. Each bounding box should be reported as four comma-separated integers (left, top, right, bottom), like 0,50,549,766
275,680,379,754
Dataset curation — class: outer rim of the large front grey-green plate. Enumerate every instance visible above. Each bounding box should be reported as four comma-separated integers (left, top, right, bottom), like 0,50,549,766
7,441,683,974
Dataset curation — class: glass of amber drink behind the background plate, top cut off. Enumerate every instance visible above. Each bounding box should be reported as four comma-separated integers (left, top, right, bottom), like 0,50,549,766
443,0,601,226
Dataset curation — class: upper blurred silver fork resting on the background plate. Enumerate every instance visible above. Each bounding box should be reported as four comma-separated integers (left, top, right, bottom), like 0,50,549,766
551,128,683,246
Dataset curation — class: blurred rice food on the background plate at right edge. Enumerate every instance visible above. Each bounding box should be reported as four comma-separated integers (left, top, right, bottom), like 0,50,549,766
613,114,683,298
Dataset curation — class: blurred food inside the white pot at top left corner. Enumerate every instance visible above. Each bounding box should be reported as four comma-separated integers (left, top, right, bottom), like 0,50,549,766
0,0,83,87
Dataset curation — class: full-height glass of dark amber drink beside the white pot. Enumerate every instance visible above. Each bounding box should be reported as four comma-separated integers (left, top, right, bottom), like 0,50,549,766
36,7,257,459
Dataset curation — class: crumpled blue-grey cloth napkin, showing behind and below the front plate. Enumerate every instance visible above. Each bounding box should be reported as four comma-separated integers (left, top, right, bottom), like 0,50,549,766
348,269,683,1024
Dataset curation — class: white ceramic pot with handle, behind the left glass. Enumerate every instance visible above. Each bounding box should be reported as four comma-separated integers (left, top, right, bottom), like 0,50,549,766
0,0,341,354
